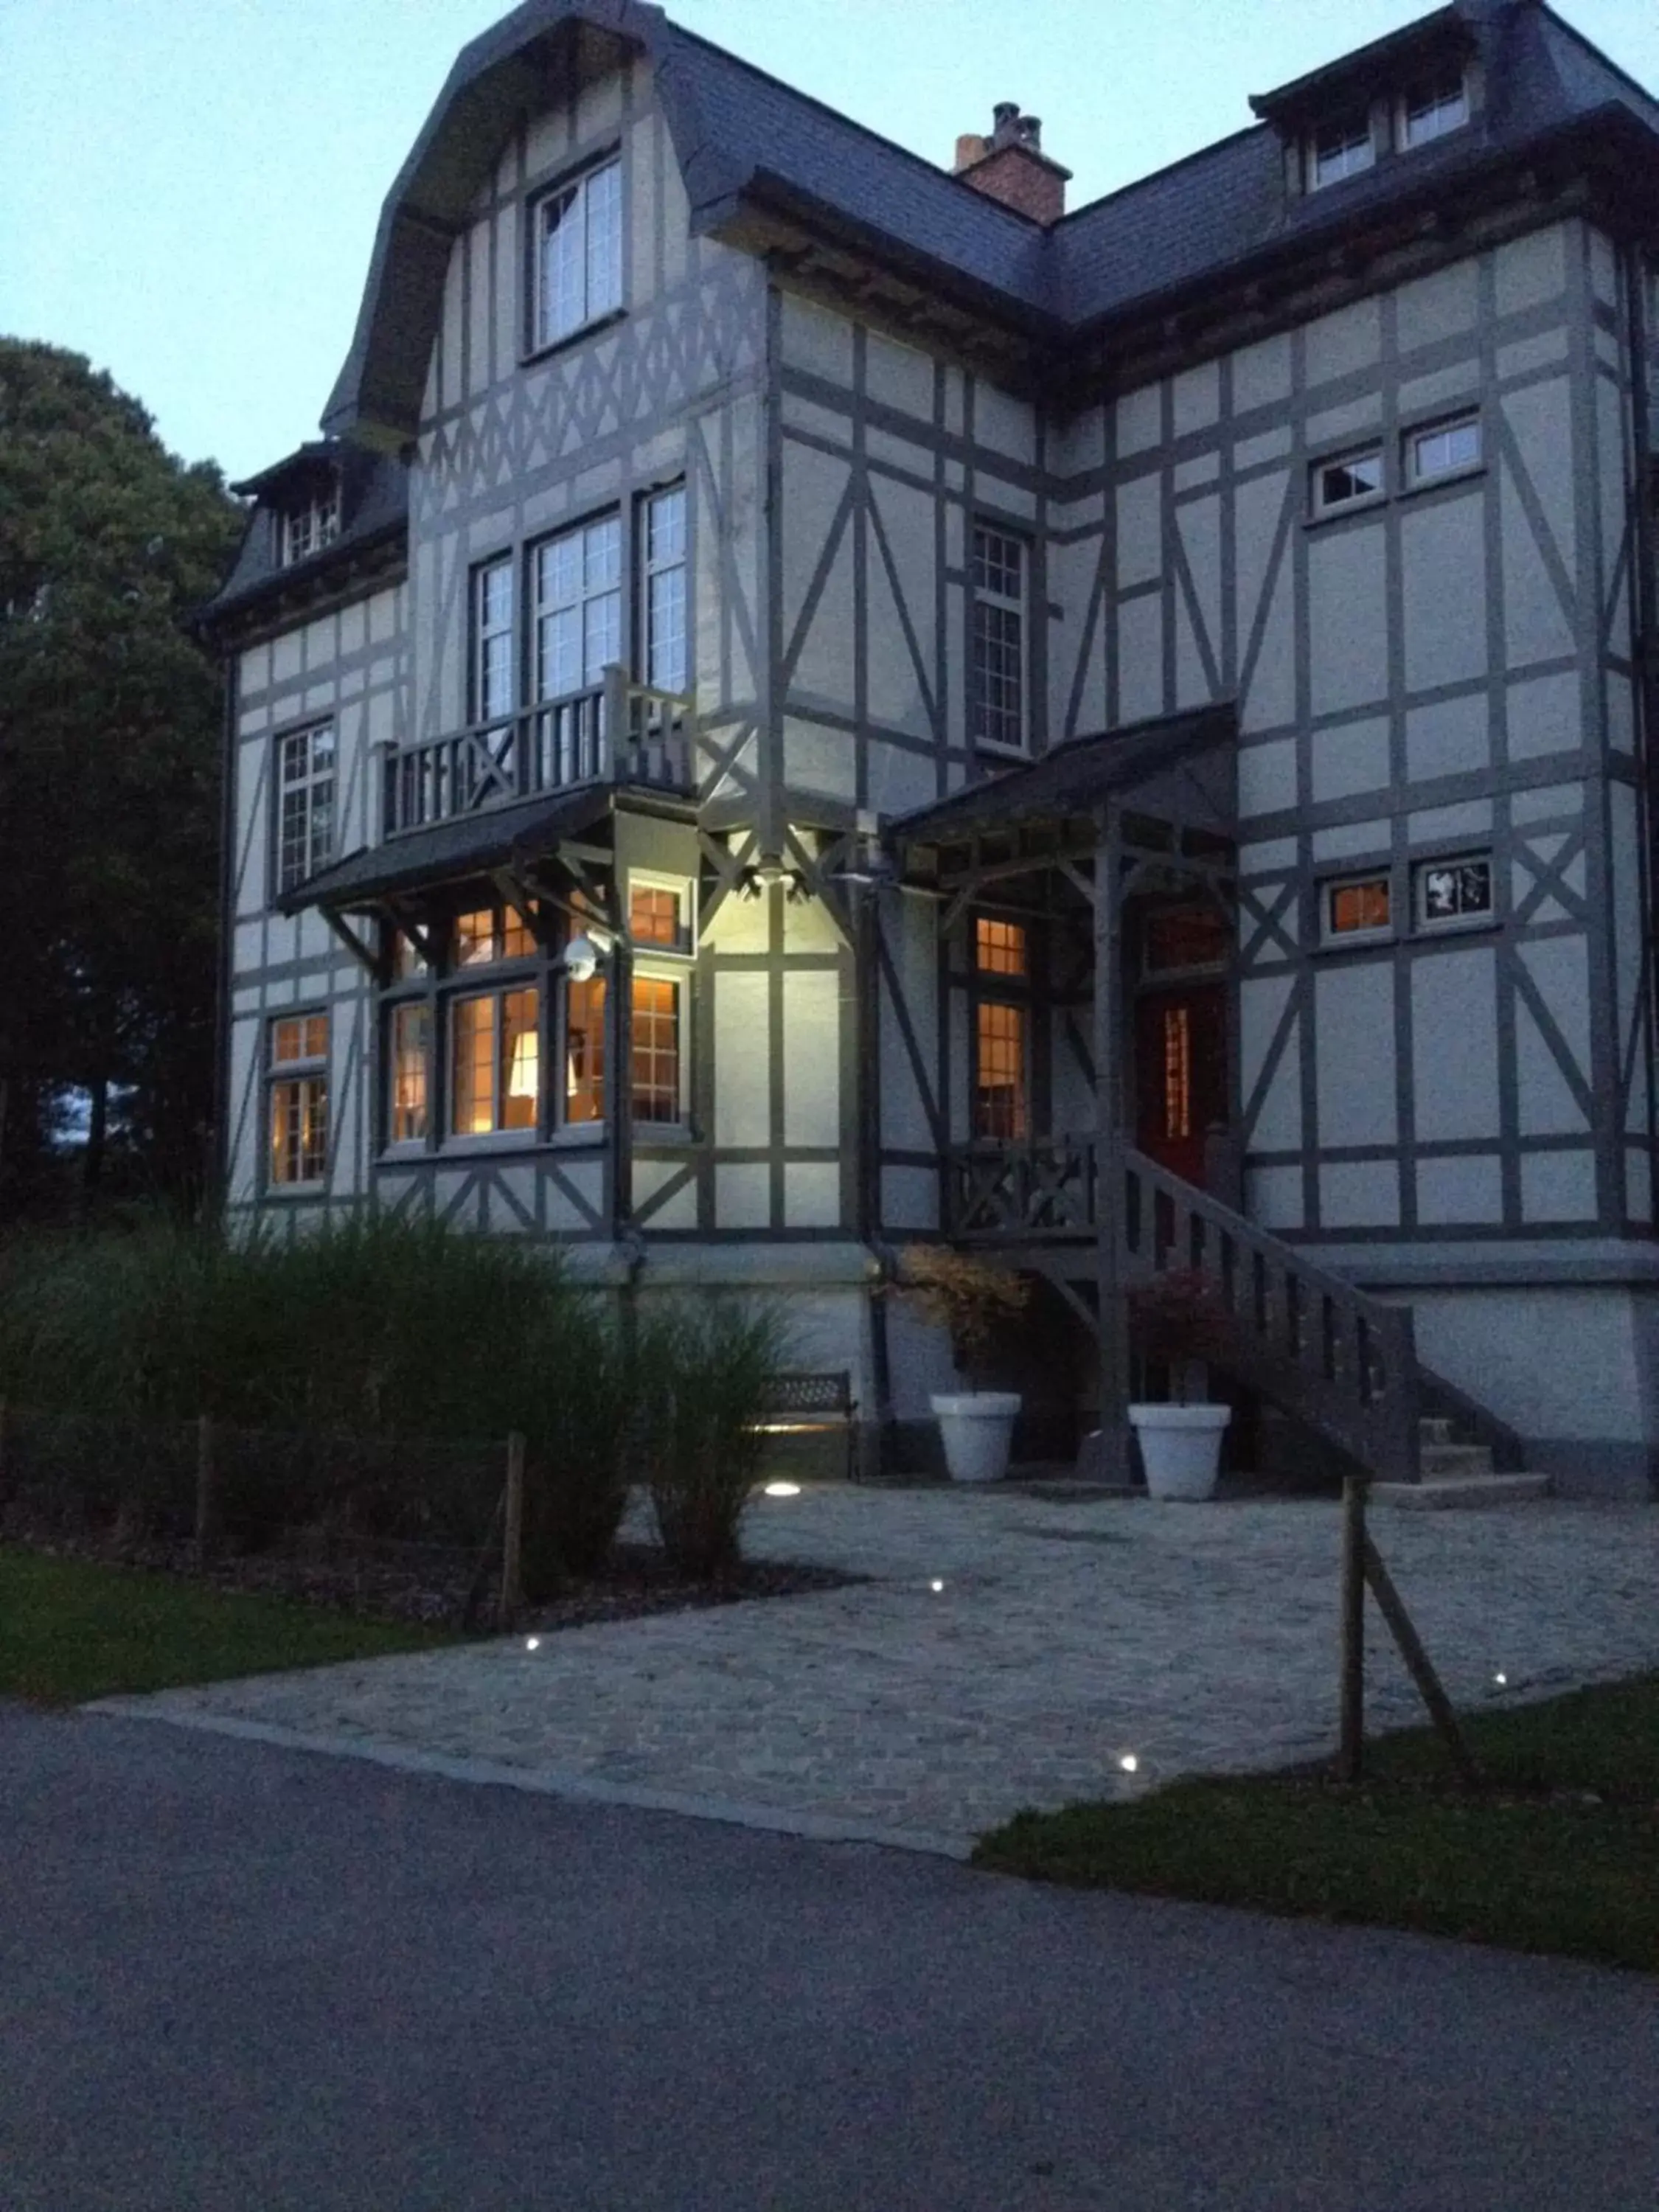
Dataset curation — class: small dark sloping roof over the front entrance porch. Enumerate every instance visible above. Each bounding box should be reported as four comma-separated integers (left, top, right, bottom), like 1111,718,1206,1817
889,701,1239,847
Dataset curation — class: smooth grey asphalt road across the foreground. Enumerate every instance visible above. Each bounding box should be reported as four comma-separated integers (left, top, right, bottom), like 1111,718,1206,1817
0,1708,1659,2212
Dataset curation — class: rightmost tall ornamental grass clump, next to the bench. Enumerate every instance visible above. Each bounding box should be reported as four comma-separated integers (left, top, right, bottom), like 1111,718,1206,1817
635,1298,787,1582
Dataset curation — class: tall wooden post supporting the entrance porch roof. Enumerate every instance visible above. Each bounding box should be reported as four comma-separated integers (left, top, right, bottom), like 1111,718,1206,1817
1095,799,1130,1482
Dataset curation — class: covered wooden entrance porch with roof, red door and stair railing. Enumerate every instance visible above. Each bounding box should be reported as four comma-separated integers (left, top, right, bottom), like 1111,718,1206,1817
891,706,1418,1480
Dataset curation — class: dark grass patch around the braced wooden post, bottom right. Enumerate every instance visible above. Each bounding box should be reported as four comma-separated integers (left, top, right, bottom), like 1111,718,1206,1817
973,1674,1659,1971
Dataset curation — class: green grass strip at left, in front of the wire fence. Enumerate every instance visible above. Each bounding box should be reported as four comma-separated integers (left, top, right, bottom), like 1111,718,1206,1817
0,1548,453,1705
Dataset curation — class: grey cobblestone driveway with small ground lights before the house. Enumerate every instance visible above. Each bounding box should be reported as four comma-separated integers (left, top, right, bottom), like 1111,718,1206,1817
100,1484,1659,1854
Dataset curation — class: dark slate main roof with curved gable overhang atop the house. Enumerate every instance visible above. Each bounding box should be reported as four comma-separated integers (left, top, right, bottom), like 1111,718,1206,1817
325,0,1659,438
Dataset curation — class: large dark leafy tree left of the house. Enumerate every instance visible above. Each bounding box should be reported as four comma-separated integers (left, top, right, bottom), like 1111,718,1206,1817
0,338,241,1214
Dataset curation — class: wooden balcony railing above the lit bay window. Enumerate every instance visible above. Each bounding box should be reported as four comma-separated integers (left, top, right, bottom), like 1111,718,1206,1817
383,668,695,838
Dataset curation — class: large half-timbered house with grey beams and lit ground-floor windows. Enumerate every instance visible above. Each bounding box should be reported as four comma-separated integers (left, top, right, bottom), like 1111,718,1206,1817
212,0,1659,1491
